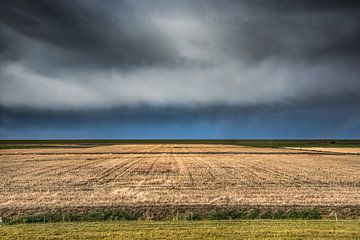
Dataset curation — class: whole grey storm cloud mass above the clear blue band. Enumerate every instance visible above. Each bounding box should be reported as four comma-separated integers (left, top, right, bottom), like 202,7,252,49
0,0,360,111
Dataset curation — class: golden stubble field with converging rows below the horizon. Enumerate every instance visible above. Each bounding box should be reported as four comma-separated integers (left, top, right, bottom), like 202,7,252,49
0,144,360,218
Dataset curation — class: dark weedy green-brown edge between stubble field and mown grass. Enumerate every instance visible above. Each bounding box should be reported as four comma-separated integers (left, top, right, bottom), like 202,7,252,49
0,205,360,224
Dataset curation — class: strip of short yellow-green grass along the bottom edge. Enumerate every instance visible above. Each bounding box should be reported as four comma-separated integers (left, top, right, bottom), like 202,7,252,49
0,220,360,240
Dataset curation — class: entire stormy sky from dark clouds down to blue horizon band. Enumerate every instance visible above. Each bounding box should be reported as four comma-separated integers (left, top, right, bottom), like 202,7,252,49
0,0,360,139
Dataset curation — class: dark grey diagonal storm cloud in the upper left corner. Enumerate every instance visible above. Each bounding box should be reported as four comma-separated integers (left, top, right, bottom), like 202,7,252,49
0,0,179,66
